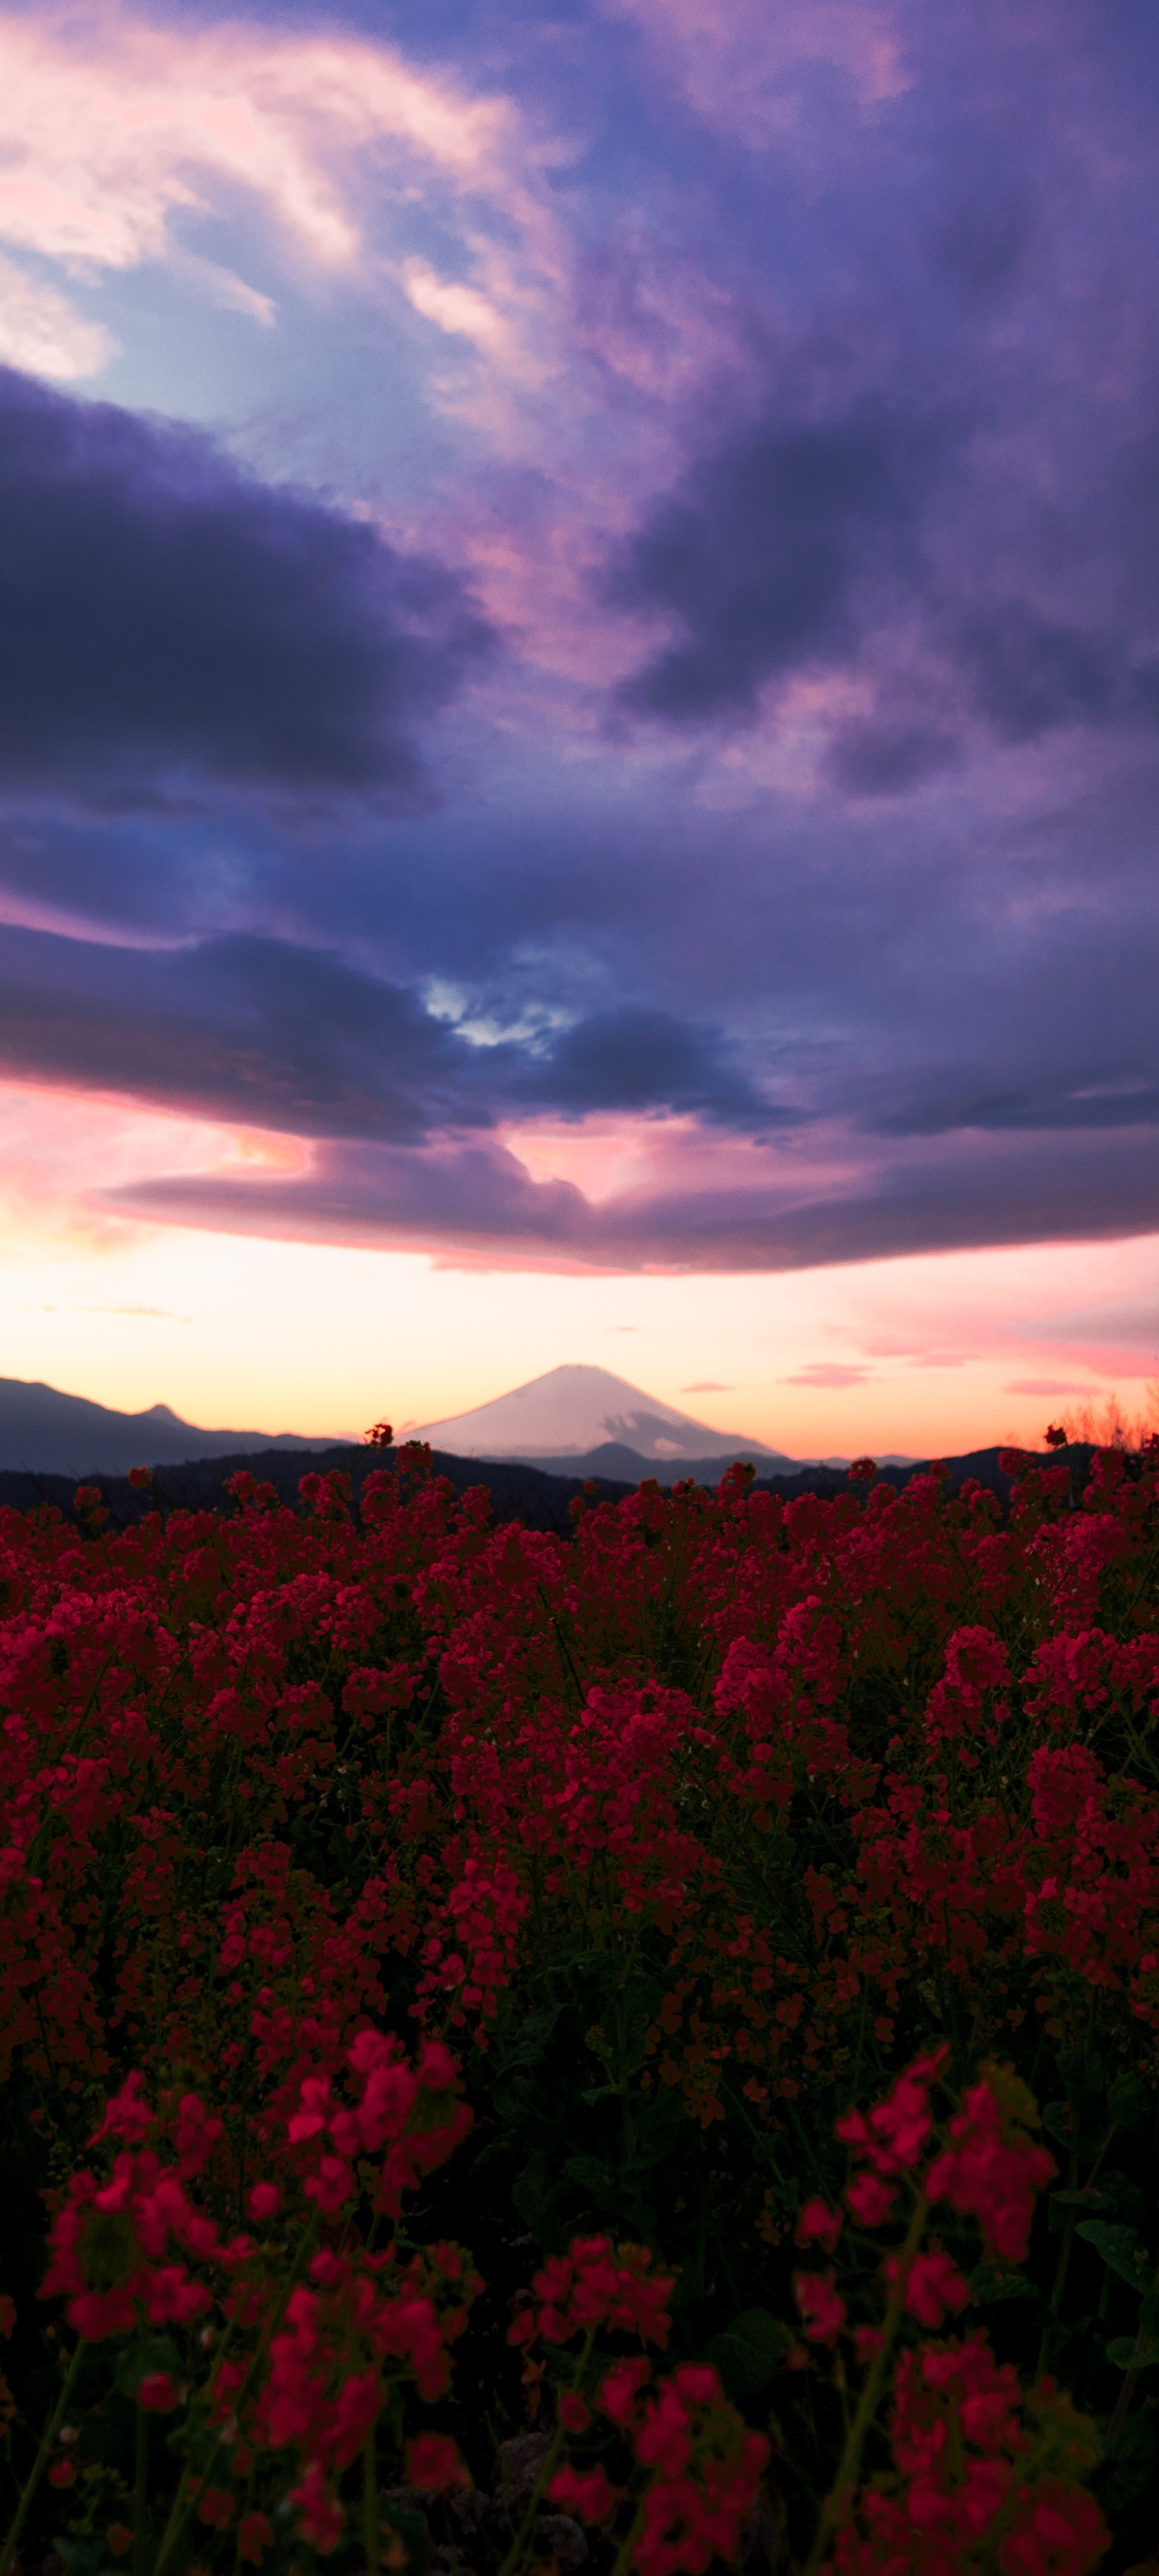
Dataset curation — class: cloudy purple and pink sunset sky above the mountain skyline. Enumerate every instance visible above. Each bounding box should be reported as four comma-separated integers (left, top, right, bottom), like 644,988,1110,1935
0,0,1159,1453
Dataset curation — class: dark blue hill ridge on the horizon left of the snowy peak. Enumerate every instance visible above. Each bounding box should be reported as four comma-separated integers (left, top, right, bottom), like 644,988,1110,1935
0,1378,344,1476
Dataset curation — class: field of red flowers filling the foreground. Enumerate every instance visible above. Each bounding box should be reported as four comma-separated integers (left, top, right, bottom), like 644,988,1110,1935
0,1443,1159,2576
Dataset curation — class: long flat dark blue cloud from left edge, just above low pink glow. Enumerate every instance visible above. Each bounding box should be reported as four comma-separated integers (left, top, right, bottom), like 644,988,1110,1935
0,930,798,1144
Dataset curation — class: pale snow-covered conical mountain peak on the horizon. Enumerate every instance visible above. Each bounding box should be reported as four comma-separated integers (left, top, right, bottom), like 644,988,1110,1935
407,1363,796,1476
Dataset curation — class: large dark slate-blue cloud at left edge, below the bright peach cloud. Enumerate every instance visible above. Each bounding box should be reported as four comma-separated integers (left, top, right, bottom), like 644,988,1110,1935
0,369,489,807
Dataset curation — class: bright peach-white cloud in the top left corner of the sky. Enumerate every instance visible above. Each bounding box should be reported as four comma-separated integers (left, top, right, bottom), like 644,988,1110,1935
0,10,518,270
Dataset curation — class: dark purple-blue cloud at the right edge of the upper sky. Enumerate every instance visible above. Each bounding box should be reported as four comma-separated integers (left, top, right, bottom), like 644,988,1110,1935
608,384,1159,773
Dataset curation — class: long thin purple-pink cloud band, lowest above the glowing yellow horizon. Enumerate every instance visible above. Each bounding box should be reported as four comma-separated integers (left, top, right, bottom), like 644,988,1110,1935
95,1131,1159,1273
